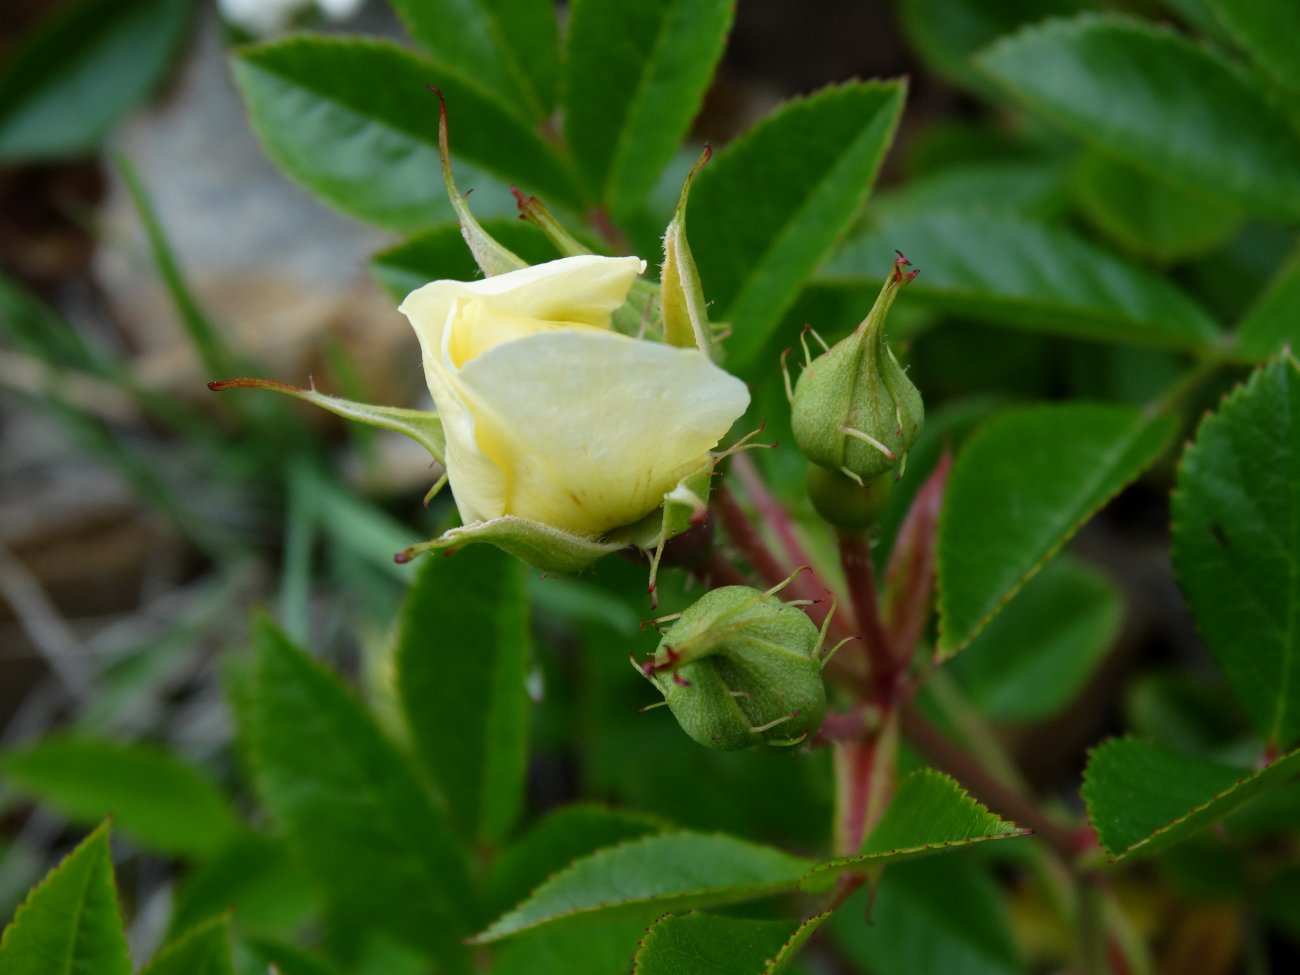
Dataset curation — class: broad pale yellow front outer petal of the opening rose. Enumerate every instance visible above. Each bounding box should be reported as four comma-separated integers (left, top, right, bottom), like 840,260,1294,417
449,330,749,536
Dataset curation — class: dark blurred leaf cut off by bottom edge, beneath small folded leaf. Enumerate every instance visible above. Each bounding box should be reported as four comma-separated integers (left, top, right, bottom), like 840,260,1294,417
829,857,1026,975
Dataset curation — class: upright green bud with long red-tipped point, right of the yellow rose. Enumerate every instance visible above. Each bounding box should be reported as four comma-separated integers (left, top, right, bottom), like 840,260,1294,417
787,254,926,484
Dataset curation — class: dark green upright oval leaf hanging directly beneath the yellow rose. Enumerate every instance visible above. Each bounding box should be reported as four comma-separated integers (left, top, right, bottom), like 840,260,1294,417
395,546,530,844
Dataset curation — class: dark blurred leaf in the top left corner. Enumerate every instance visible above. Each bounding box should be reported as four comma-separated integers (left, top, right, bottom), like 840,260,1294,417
0,0,190,160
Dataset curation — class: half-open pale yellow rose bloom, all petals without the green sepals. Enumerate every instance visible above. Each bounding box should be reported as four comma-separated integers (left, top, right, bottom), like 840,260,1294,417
400,255,749,538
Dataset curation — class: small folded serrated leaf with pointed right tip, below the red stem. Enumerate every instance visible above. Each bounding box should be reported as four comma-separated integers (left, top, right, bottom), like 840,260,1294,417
807,768,1031,885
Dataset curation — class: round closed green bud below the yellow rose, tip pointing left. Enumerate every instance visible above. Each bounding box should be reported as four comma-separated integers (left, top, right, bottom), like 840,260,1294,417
638,586,829,751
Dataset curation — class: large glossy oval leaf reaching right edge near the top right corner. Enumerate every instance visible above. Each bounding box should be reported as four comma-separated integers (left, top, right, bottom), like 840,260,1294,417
976,16,1300,217
